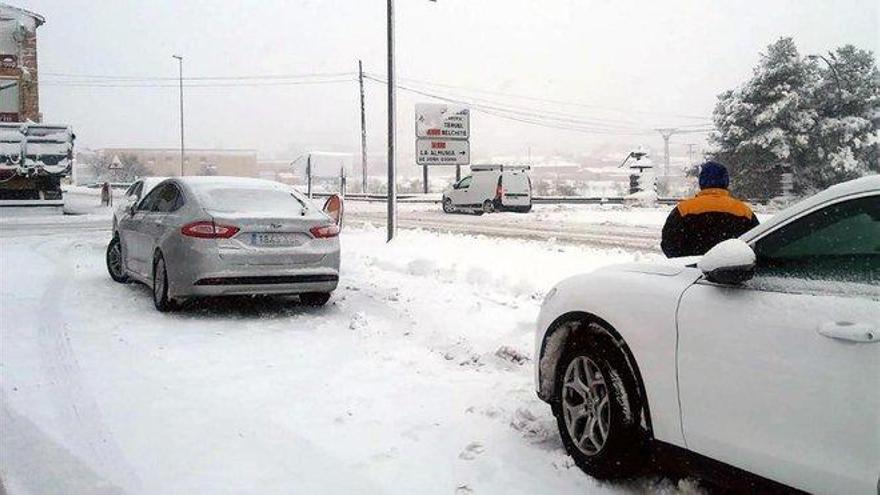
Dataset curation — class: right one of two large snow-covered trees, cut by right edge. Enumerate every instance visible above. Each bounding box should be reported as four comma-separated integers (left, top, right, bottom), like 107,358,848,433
795,45,880,192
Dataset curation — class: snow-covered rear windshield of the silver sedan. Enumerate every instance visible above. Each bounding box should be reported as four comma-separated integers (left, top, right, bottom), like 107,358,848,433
199,188,305,213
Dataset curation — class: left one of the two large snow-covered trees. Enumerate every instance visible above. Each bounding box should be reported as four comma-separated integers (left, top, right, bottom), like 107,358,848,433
711,38,817,198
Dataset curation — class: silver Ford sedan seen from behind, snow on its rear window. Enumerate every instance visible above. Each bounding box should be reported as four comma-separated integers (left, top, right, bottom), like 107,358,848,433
107,177,341,311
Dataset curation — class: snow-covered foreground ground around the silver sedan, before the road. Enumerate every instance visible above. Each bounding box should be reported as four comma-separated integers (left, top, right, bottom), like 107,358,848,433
0,196,696,494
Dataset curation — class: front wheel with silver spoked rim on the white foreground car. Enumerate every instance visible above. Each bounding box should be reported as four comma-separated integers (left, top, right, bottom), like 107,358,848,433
552,333,648,480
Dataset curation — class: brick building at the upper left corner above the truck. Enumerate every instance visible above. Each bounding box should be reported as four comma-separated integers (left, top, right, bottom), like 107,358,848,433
0,3,46,122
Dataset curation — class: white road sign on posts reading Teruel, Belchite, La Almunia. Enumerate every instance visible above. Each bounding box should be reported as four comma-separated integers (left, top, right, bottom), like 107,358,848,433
416,103,471,189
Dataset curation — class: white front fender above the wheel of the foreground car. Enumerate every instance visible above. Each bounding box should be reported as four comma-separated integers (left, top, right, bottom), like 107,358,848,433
535,264,701,447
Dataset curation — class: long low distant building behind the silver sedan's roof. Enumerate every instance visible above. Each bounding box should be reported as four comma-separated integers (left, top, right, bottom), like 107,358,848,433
95,148,260,177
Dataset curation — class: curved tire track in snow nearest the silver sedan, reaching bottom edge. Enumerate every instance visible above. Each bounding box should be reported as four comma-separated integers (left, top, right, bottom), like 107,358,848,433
35,238,140,492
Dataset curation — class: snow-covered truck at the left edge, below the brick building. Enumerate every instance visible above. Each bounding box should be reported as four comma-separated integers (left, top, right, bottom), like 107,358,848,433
0,122,76,207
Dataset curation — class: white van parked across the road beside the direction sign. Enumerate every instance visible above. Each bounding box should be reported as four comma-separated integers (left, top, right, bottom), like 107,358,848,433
443,165,532,213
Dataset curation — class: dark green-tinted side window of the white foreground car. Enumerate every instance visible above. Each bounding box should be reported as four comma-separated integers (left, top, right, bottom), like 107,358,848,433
755,195,880,283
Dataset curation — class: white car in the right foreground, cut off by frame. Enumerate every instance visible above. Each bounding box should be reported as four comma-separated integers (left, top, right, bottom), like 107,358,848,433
535,176,880,495
